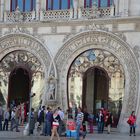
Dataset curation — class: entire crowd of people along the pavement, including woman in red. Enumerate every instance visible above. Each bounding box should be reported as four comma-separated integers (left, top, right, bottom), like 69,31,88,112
0,103,136,140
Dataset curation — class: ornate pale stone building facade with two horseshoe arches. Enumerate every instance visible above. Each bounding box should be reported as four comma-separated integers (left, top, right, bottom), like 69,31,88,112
0,0,140,132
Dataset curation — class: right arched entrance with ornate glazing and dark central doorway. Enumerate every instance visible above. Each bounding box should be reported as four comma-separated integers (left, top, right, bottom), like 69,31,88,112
68,49,125,126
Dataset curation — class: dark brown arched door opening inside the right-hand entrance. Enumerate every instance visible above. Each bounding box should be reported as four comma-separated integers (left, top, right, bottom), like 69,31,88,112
82,67,109,114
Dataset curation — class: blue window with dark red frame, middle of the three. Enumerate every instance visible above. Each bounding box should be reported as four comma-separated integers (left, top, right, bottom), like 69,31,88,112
46,0,73,10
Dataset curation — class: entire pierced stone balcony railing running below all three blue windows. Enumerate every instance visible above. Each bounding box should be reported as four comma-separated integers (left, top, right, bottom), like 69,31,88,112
4,6,114,22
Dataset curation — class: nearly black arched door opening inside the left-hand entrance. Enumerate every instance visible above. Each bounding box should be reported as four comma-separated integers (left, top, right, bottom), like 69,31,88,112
8,67,31,107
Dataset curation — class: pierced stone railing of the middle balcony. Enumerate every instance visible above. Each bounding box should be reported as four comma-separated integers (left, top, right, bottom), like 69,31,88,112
40,9,73,21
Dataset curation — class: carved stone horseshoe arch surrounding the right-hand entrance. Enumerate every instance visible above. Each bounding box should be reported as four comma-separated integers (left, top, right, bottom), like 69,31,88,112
55,31,139,131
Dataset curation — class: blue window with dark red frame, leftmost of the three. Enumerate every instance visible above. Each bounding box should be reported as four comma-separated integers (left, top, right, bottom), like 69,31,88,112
10,0,36,12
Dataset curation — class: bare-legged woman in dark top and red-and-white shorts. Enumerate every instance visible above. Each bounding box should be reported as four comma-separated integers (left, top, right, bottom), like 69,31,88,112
50,109,61,140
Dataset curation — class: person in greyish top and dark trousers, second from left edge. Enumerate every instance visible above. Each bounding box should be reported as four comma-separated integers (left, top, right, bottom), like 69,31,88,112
3,108,10,131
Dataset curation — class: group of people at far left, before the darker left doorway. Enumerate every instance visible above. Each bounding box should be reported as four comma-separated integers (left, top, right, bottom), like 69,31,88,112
0,103,27,132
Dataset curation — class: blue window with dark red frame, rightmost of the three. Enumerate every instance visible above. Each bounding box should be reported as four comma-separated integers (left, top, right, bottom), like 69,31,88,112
84,0,113,8
